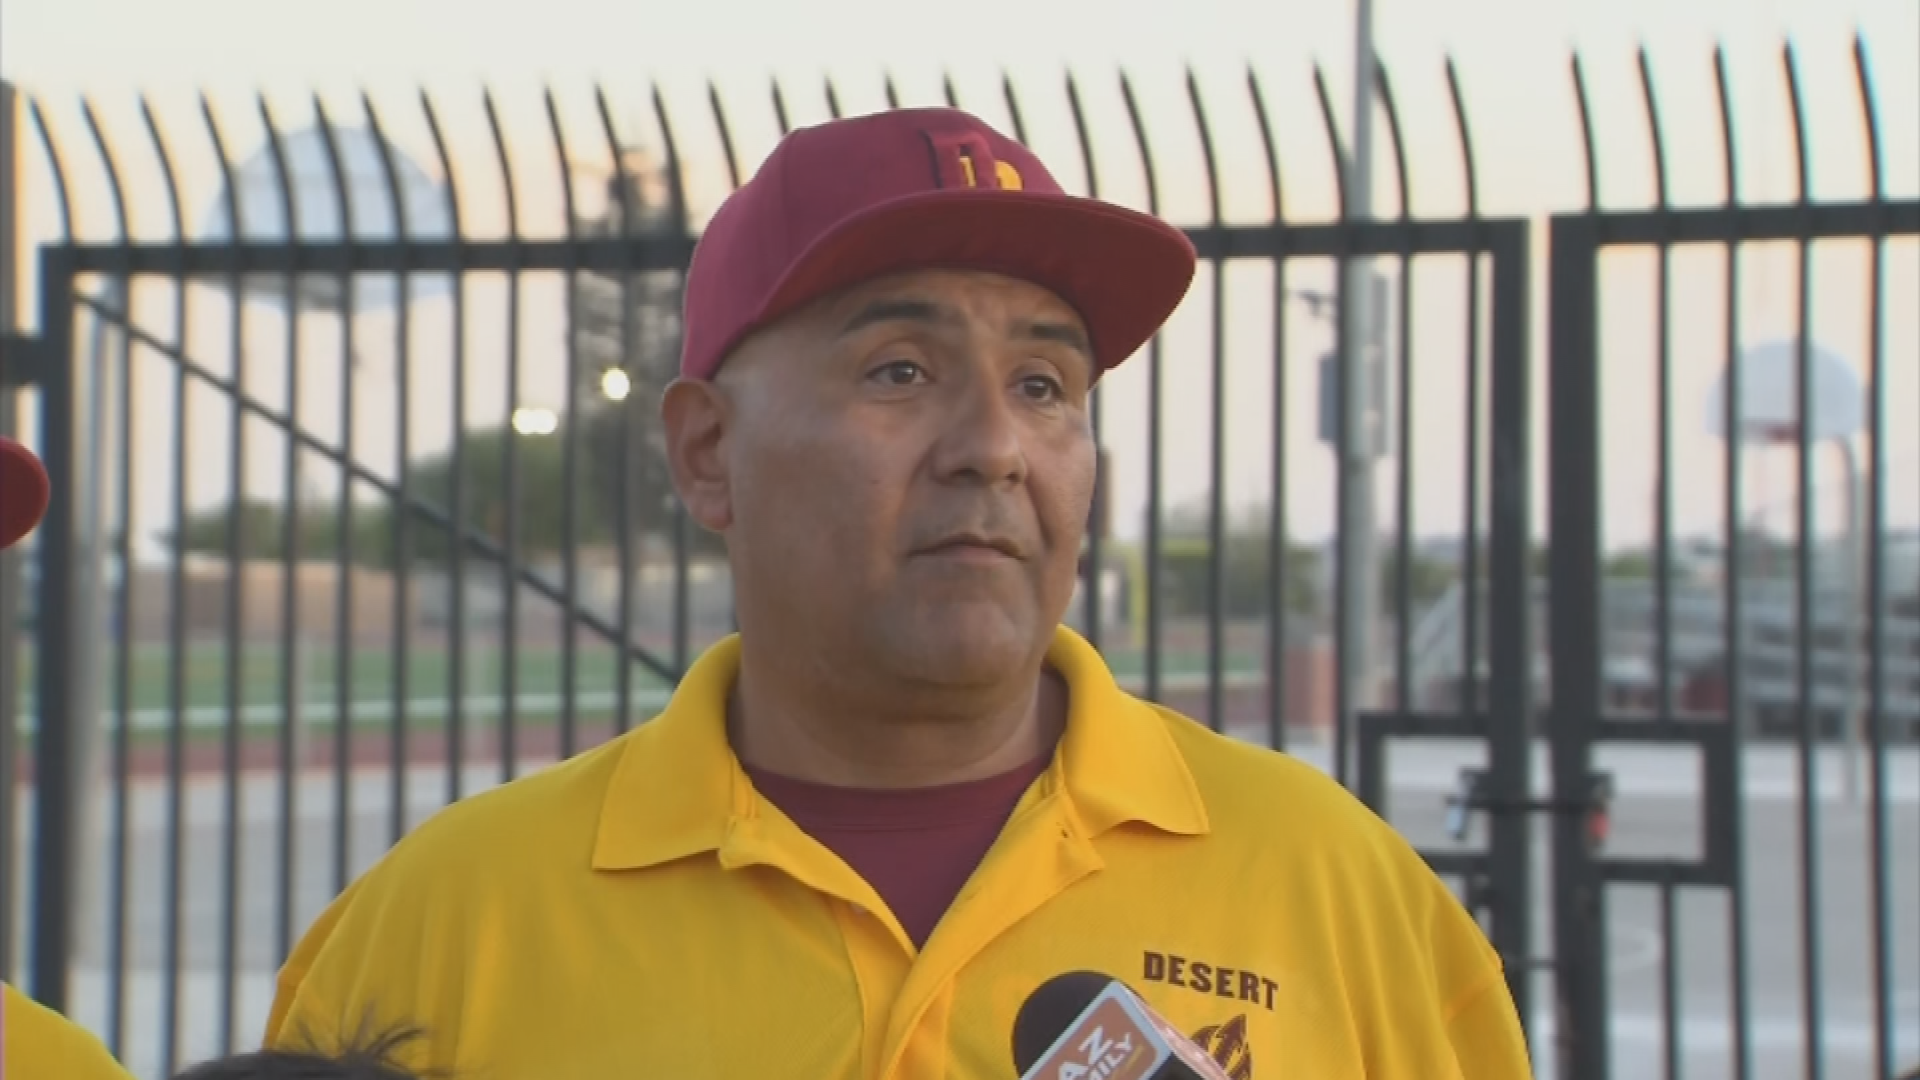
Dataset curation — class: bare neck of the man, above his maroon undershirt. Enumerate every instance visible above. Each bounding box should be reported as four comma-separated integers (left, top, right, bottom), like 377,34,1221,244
728,655,1068,788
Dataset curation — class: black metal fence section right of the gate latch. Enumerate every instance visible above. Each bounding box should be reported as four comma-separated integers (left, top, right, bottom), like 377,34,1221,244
1548,44,1920,1076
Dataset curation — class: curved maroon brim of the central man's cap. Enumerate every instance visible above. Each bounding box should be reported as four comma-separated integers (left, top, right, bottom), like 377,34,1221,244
755,190,1194,371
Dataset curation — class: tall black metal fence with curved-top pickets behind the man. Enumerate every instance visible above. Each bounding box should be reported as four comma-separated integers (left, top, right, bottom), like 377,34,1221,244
0,39,1920,1078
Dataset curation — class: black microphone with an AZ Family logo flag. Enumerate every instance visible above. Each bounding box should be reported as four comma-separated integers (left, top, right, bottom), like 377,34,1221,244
1014,970,1229,1080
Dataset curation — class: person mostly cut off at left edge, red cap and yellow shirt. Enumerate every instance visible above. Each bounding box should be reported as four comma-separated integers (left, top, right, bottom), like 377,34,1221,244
0,436,131,1080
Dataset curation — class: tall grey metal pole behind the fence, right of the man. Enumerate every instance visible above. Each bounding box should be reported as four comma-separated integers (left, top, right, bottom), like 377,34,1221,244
1334,0,1382,780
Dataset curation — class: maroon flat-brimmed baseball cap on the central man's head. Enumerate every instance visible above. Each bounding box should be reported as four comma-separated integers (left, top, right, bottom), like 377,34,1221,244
680,110,1194,379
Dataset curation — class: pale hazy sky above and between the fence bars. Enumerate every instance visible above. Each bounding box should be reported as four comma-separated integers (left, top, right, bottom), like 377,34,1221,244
0,0,1920,550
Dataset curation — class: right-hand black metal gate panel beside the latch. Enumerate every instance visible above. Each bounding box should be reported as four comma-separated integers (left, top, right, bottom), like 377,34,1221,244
1536,52,1920,1080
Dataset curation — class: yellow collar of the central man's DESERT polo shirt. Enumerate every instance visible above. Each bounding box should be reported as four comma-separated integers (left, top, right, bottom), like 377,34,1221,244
593,626,1208,871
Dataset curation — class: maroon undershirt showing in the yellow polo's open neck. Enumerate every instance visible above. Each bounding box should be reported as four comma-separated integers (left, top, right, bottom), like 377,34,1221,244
747,757,1050,947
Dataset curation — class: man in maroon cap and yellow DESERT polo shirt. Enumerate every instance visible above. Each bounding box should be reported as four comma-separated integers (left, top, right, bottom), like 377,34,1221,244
269,110,1530,1080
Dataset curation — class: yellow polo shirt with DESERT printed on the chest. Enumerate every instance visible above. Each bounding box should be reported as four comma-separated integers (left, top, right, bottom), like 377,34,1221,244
267,630,1530,1080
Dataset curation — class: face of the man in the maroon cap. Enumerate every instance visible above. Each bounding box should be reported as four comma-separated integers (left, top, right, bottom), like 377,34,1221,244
666,271,1094,686
